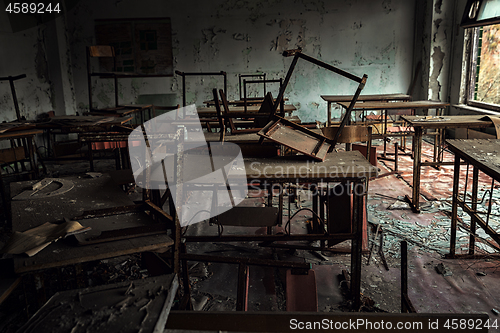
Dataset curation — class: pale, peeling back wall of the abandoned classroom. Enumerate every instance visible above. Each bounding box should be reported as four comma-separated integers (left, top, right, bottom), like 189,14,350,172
0,0,415,121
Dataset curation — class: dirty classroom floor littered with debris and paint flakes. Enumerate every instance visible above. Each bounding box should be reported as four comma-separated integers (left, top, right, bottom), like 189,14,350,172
0,137,500,332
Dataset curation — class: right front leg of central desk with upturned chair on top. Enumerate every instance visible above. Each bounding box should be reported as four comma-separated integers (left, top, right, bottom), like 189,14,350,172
351,180,366,311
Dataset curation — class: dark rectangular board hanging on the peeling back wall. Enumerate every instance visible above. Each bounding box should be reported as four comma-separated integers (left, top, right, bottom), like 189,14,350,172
95,18,174,76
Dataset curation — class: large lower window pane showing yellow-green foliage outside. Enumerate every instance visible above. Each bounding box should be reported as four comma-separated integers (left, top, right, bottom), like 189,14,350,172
473,24,500,104
